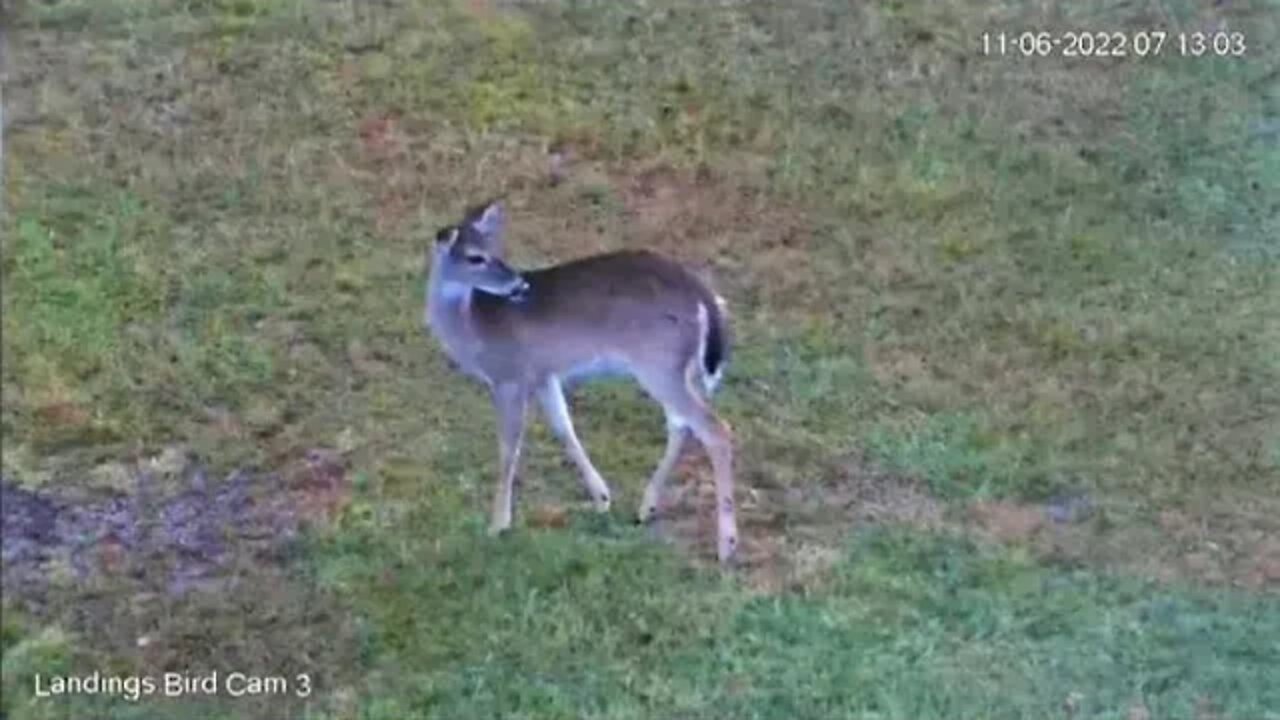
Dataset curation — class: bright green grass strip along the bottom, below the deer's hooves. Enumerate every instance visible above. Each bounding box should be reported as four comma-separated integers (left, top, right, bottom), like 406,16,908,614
335,520,1280,719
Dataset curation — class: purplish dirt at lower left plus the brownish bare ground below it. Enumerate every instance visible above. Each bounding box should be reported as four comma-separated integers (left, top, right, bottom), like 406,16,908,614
0,448,358,717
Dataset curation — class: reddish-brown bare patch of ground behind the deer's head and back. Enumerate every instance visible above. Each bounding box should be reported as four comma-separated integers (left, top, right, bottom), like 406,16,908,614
343,118,822,307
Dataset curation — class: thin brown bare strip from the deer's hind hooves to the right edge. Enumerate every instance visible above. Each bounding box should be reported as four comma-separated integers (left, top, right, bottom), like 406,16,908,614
640,447,1280,593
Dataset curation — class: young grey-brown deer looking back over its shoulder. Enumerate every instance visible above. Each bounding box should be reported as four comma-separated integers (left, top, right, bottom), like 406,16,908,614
425,201,737,562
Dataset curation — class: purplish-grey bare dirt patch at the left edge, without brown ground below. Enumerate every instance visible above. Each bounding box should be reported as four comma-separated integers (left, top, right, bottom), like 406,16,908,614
0,448,349,599
